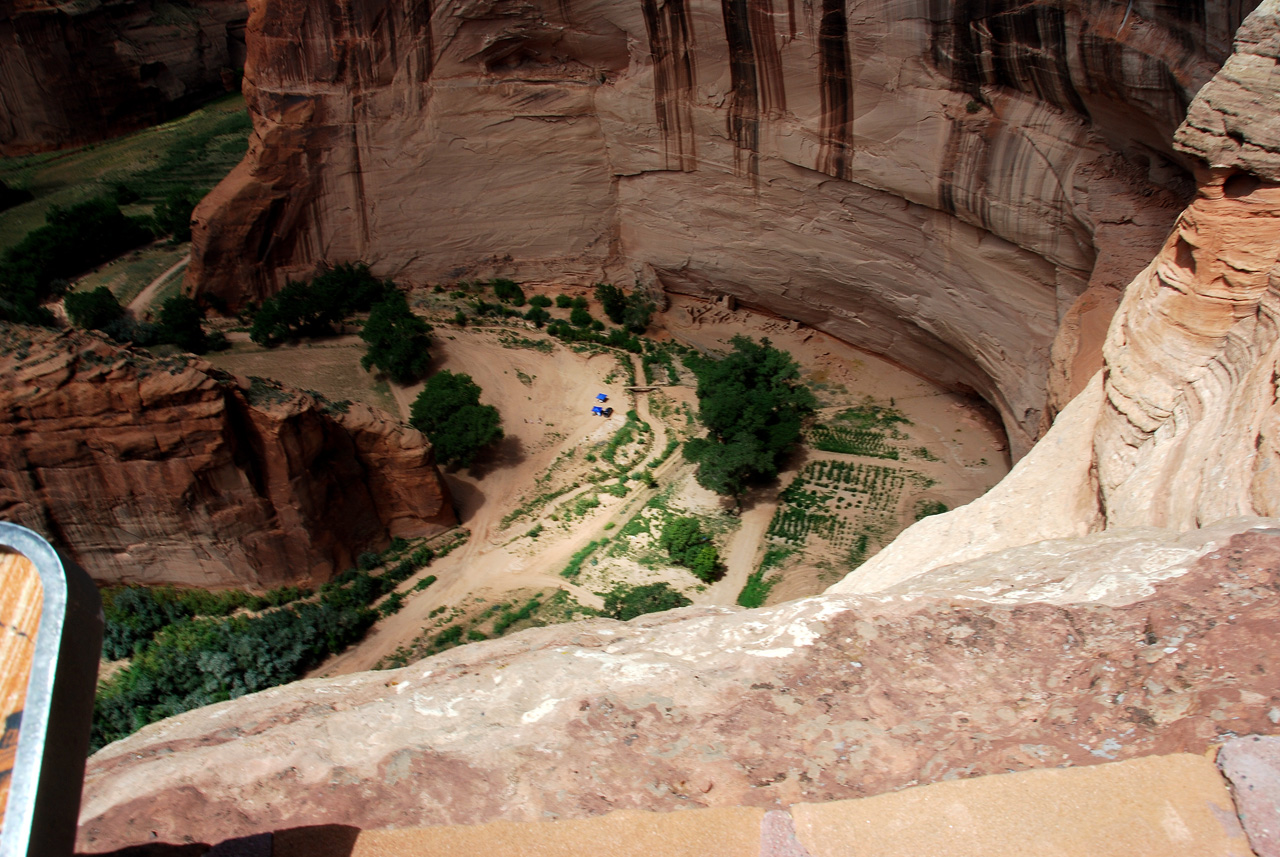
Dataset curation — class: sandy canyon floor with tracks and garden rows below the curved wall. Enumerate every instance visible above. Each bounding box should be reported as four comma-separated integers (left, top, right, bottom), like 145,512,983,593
202,294,1009,675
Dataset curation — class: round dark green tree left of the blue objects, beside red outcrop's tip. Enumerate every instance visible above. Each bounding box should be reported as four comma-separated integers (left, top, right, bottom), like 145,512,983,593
410,370,503,467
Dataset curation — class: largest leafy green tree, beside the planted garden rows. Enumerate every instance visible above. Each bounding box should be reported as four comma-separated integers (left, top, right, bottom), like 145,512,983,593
685,336,817,499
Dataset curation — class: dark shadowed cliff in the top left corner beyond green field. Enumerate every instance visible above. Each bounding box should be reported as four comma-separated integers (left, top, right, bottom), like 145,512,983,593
0,0,248,156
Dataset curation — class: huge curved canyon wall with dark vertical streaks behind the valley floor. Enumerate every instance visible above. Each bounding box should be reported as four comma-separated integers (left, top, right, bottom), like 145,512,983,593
188,0,1254,455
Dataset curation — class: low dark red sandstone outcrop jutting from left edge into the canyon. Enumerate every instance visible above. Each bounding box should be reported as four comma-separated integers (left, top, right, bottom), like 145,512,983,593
0,326,454,588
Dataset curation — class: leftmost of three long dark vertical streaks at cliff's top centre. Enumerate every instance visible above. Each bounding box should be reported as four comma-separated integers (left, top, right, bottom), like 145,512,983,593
641,0,698,173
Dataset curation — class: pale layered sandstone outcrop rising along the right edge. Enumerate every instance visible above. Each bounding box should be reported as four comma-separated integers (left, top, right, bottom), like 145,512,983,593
833,0,1280,592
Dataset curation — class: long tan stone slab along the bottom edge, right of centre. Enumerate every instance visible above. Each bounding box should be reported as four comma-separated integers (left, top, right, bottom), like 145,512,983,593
791,753,1252,857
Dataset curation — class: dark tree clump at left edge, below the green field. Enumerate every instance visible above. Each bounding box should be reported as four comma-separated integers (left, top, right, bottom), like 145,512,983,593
0,197,151,325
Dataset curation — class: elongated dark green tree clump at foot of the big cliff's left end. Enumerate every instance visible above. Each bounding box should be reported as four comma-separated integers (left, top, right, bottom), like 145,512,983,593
250,262,394,345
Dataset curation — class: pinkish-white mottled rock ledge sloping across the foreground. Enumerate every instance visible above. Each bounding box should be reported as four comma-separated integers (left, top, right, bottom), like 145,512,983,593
79,522,1280,852
